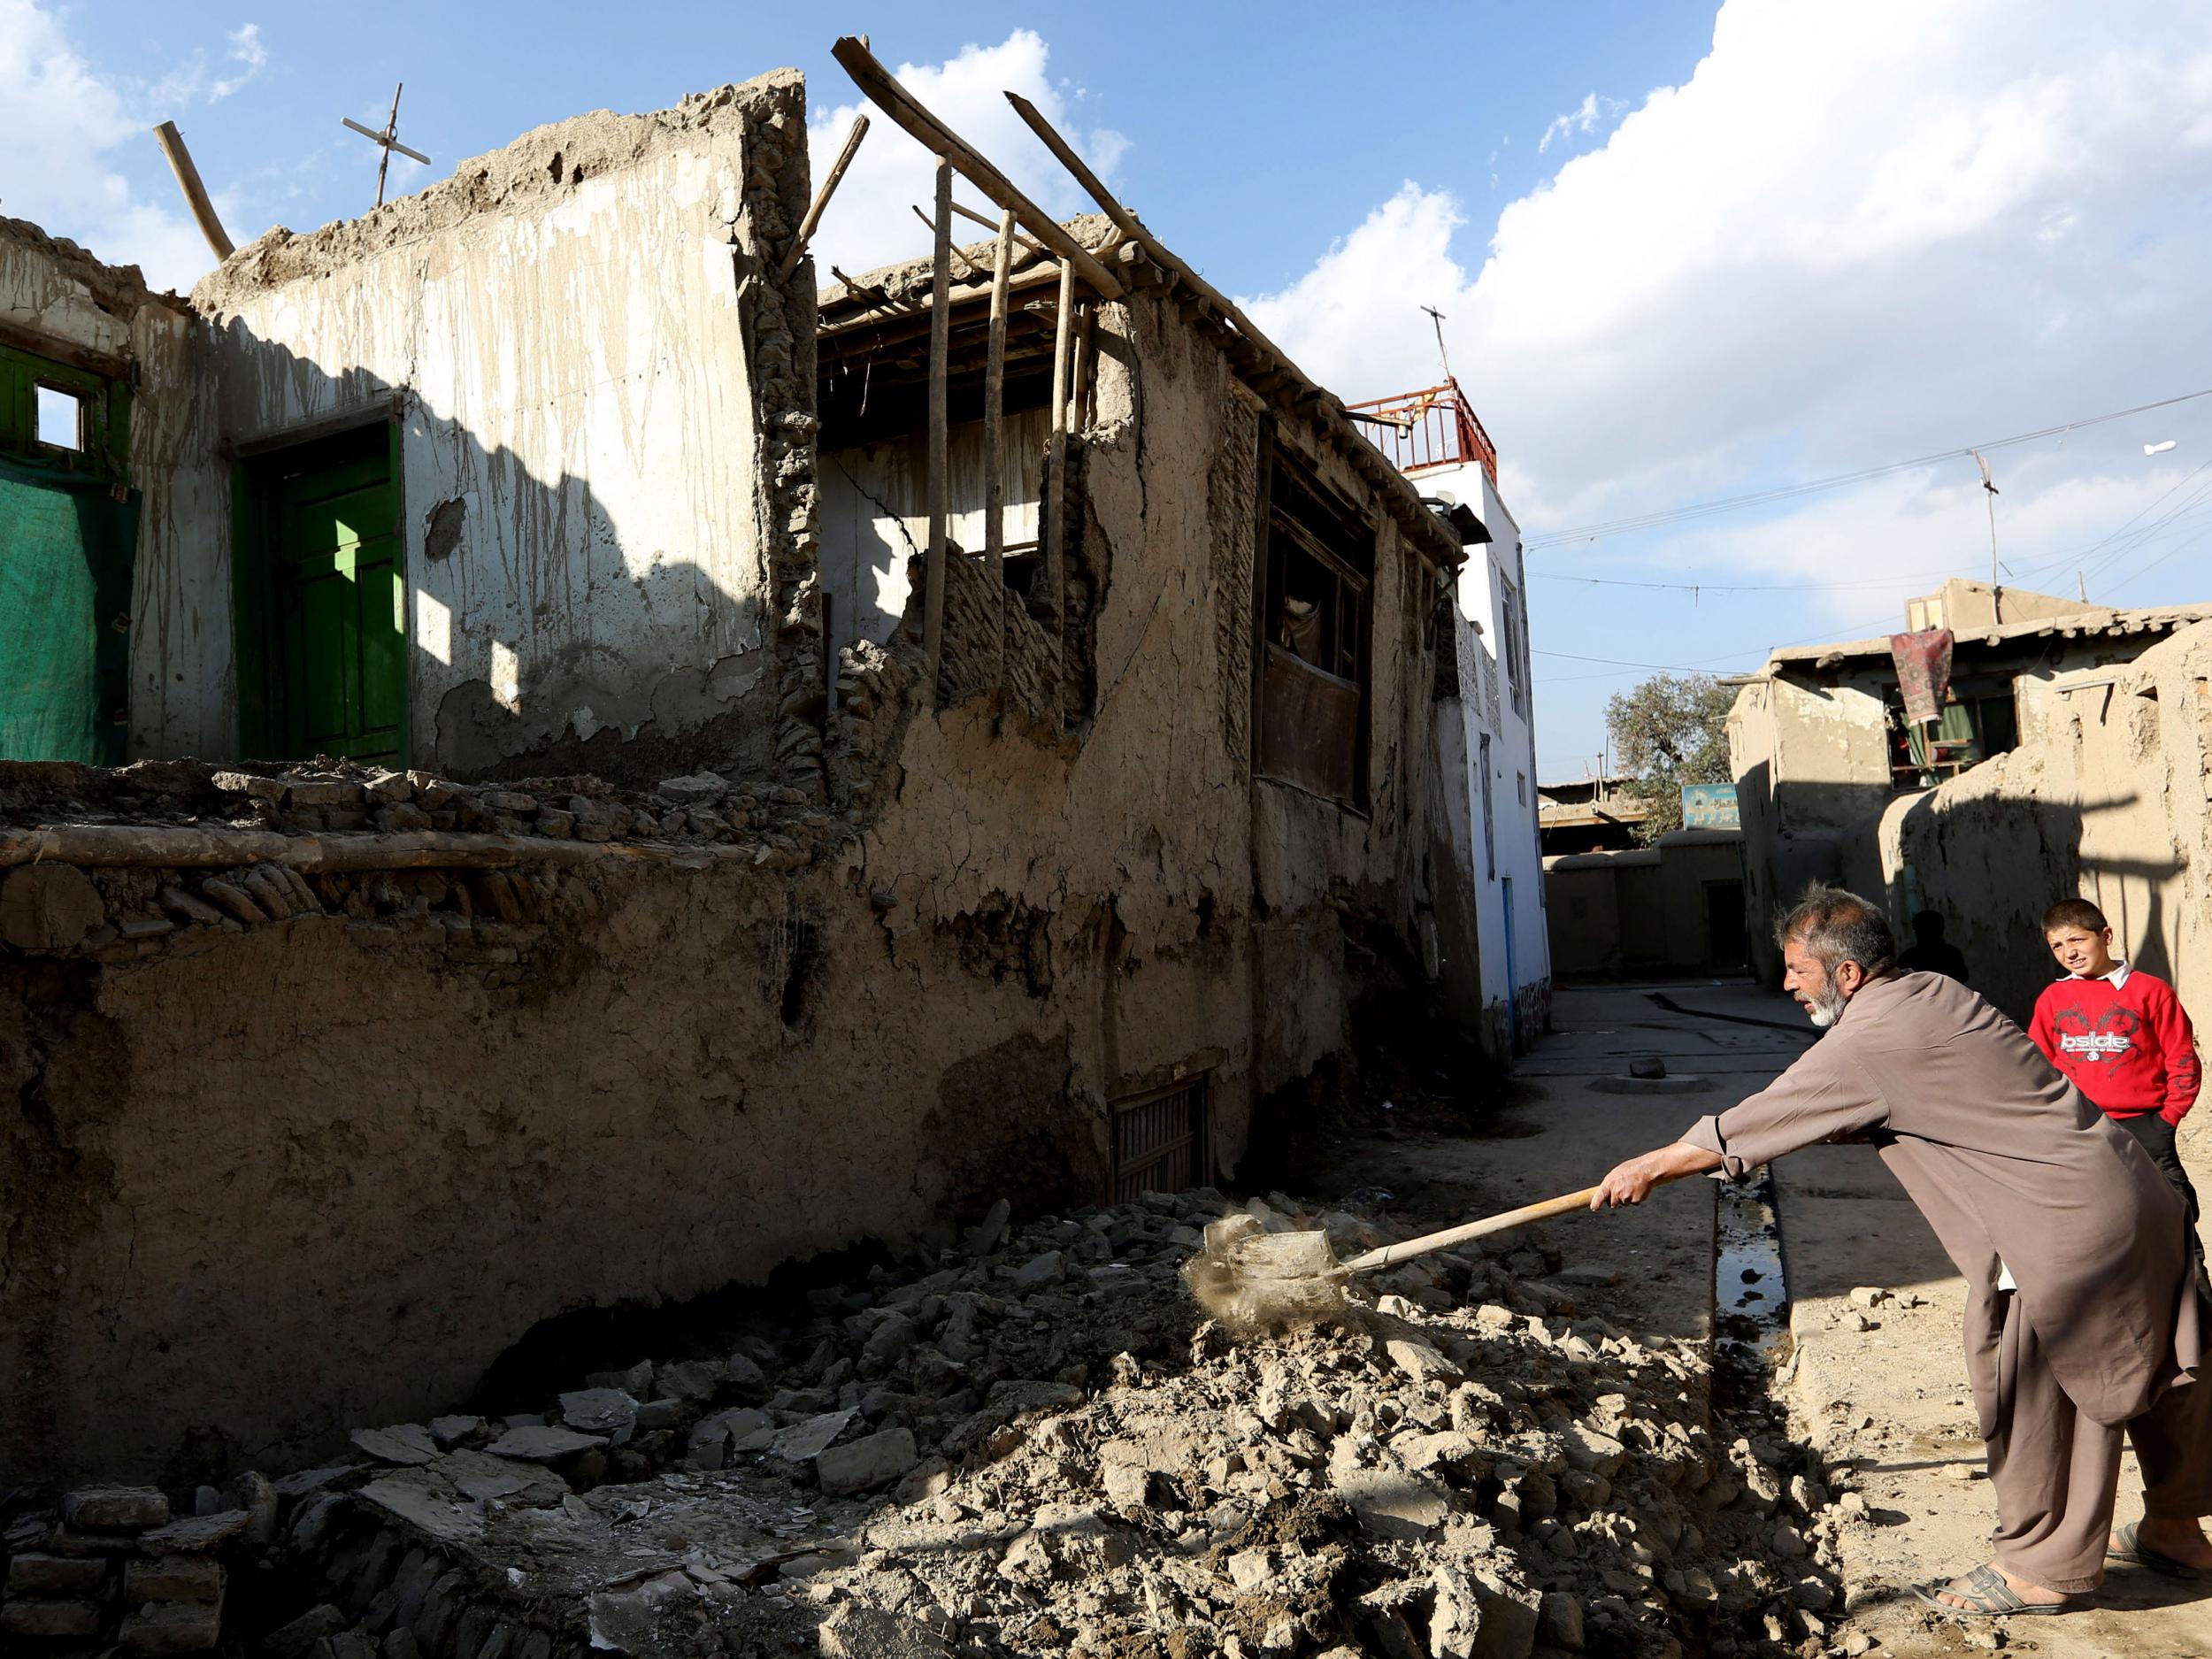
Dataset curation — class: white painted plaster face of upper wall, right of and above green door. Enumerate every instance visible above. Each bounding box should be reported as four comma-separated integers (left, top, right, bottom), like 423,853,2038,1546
201,119,774,772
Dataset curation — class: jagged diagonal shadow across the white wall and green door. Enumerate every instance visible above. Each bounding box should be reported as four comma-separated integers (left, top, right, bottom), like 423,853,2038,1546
213,319,796,787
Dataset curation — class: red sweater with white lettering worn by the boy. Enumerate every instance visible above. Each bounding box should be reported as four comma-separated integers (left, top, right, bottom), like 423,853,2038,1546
2029,969,2201,1124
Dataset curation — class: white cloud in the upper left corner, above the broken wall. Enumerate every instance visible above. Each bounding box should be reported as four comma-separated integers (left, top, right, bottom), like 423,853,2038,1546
0,0,268,288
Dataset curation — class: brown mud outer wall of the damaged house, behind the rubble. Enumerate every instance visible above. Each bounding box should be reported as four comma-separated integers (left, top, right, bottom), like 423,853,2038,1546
0,204,1469,1480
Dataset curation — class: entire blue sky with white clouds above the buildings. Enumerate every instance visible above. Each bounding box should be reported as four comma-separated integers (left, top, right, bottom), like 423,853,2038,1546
0,0,2212,779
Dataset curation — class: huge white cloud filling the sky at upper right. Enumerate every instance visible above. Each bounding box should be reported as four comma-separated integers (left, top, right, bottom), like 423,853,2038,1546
1250,0,2212,628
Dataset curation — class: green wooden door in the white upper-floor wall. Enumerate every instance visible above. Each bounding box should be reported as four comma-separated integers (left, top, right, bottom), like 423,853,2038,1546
270,454,407,761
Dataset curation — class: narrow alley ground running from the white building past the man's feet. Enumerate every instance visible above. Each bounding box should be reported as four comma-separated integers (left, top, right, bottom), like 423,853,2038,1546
1522,985,2212,1659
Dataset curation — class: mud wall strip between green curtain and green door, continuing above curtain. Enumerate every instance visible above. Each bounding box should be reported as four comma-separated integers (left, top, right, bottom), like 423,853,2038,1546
0,219,237,759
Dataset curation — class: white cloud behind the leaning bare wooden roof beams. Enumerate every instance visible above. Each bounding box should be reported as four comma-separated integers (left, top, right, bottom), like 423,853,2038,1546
808,29,1128,286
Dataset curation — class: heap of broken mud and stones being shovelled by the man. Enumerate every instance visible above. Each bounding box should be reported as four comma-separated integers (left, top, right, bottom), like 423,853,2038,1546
12,1190,1849,1659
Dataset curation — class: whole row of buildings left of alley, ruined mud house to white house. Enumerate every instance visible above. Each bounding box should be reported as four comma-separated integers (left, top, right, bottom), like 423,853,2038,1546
0,19,1548,1566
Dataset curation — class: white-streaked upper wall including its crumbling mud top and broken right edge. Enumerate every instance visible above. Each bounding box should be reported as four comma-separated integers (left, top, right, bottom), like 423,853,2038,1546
195,71,823,801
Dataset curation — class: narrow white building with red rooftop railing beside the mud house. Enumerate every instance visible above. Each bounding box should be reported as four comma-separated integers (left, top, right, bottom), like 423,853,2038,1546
1358,380,1551,1057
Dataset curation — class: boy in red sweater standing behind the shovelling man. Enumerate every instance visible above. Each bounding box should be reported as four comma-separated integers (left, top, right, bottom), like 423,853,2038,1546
2029,898,2201,1228
